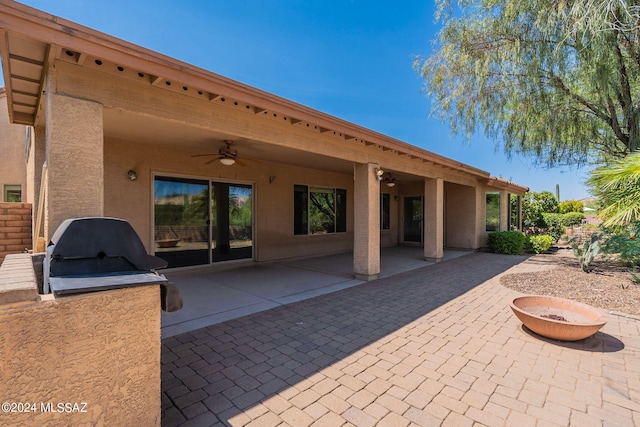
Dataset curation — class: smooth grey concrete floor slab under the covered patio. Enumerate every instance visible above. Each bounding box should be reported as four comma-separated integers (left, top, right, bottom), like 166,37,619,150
162,246,472,338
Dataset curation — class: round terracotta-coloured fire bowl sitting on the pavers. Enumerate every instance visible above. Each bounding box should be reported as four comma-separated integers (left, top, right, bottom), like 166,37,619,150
511,295,608,341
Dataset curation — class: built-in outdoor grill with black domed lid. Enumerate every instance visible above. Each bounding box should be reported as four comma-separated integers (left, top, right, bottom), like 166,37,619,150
43,217,182,311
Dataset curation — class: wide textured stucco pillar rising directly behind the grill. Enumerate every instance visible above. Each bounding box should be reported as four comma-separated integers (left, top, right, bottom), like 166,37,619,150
44,91,104,240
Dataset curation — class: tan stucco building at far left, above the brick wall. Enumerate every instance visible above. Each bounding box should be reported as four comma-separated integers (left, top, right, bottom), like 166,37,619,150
0,88,27,202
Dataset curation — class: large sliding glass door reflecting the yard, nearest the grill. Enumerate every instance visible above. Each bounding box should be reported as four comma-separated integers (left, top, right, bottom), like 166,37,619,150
154,176,253,268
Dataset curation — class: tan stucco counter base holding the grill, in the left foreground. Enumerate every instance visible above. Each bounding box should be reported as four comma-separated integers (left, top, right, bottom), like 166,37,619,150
0,255,160,426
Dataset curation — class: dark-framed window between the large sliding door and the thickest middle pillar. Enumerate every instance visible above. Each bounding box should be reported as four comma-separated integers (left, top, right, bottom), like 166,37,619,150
293,185,347,234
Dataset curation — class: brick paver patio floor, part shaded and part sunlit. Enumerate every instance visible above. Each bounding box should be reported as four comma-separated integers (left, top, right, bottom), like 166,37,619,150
162,253,640,427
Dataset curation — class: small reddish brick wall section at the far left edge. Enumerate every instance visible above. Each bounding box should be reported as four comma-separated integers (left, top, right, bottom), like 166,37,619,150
0,203,31,264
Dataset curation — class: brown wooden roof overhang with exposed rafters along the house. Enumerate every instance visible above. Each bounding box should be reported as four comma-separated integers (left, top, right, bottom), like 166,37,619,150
0,0,527,193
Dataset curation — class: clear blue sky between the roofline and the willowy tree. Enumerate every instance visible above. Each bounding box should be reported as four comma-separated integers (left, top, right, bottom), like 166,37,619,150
13,0,589,200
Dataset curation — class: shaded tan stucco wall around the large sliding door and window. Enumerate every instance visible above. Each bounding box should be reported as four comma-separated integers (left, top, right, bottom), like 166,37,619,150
104,140,354,261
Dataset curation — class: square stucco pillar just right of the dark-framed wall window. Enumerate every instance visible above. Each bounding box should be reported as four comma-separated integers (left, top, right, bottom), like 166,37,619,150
353,163,380,280
